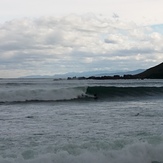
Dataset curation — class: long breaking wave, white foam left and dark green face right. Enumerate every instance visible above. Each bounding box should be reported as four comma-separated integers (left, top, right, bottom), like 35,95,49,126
0,86,163,103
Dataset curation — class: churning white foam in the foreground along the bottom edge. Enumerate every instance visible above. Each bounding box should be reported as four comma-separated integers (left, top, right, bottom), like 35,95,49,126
0,143,163,163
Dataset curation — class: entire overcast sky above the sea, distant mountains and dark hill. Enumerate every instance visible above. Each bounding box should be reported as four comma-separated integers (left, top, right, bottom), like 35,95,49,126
0,0,163,78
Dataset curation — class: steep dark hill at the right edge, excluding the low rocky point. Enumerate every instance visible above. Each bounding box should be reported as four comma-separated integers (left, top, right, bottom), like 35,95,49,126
134,62,163,79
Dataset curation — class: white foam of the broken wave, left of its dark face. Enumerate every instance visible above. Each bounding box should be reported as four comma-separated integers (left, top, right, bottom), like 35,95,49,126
0,87,86,102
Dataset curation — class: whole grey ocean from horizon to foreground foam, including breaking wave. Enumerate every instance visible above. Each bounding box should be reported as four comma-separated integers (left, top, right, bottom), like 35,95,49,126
0,79,163,163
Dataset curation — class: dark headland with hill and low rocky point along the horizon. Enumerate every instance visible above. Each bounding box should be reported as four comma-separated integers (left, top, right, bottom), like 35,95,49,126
67,62,163,80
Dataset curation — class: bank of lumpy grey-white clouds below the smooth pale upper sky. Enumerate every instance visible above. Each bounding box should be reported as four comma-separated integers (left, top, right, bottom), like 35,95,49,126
0,14,163,77
